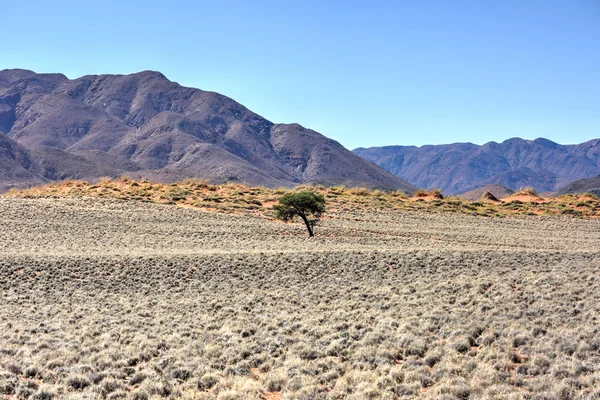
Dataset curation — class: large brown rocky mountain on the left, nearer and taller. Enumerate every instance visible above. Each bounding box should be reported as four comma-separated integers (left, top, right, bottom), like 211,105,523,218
0,70,416,192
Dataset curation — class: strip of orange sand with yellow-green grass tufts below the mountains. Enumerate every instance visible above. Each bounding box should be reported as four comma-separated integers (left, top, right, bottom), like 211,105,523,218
5,177,600,219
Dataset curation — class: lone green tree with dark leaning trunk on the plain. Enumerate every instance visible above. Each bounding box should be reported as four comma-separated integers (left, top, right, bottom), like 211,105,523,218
273,191,325,236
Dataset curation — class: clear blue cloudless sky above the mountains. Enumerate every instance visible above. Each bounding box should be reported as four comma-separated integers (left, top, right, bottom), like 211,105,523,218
0,0,600,148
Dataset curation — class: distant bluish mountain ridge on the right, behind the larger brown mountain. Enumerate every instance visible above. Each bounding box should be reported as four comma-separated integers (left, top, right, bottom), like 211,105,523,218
354,138,600,194
